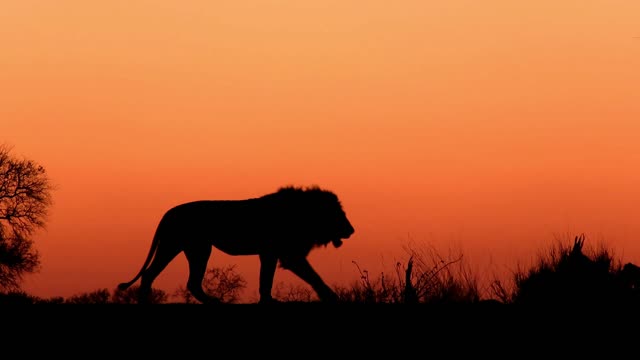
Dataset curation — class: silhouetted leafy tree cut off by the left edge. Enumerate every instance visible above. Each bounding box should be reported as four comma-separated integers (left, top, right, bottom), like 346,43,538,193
0,146,52,290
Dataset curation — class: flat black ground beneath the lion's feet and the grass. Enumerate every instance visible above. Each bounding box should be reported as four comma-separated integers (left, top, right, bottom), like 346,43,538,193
0,303,640,359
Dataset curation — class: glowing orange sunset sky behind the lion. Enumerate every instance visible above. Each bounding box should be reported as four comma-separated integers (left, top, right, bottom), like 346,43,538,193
0,0,640,296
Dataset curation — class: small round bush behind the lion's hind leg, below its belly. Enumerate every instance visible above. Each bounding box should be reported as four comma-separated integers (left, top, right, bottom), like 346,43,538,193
173,265,247,304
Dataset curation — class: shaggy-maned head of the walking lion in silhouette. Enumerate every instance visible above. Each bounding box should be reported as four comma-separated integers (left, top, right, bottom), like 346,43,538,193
274,186,355,248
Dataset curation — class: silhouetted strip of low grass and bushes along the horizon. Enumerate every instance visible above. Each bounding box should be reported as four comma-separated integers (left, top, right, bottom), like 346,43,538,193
0,236,640,306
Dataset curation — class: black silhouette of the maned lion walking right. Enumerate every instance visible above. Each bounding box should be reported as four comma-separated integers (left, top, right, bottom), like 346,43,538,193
118,186,355,303
